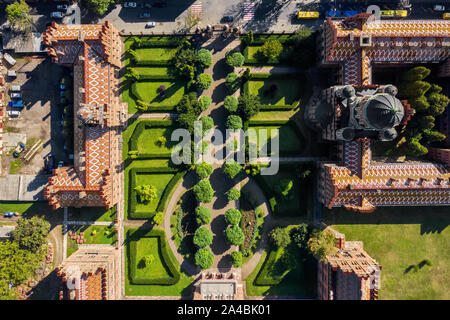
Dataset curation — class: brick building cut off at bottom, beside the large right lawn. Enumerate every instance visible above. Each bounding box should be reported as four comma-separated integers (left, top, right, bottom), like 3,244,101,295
317,227,381,300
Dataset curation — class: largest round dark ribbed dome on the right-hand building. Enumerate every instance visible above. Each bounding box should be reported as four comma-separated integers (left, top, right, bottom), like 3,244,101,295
364,93,405,129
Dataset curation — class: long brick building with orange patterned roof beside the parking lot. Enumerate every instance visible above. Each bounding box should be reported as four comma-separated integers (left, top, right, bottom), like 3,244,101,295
43,22,127,209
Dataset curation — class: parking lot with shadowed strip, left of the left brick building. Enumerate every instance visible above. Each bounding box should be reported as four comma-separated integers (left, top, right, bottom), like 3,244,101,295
2,57,69,174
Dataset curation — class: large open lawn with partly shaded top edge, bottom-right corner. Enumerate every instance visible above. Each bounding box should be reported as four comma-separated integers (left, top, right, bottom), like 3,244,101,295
323,207,450,300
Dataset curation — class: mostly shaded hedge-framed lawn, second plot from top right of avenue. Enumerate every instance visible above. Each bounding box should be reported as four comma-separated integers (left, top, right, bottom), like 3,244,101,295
248,76,305,107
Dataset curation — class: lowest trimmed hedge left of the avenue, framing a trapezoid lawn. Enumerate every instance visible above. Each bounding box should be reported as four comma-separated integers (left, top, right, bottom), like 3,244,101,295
127,229,181,285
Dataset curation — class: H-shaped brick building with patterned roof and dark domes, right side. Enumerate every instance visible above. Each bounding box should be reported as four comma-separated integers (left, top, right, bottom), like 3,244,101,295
312,14,450,212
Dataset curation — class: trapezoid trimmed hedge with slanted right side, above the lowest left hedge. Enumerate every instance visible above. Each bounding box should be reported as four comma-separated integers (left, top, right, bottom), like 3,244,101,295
128,167,186,219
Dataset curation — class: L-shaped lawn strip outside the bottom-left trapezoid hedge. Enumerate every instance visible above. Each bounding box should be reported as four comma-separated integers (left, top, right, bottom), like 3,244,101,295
125,228,194,297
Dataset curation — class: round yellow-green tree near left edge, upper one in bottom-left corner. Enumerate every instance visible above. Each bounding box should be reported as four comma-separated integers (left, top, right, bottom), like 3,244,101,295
12,216,50,251
